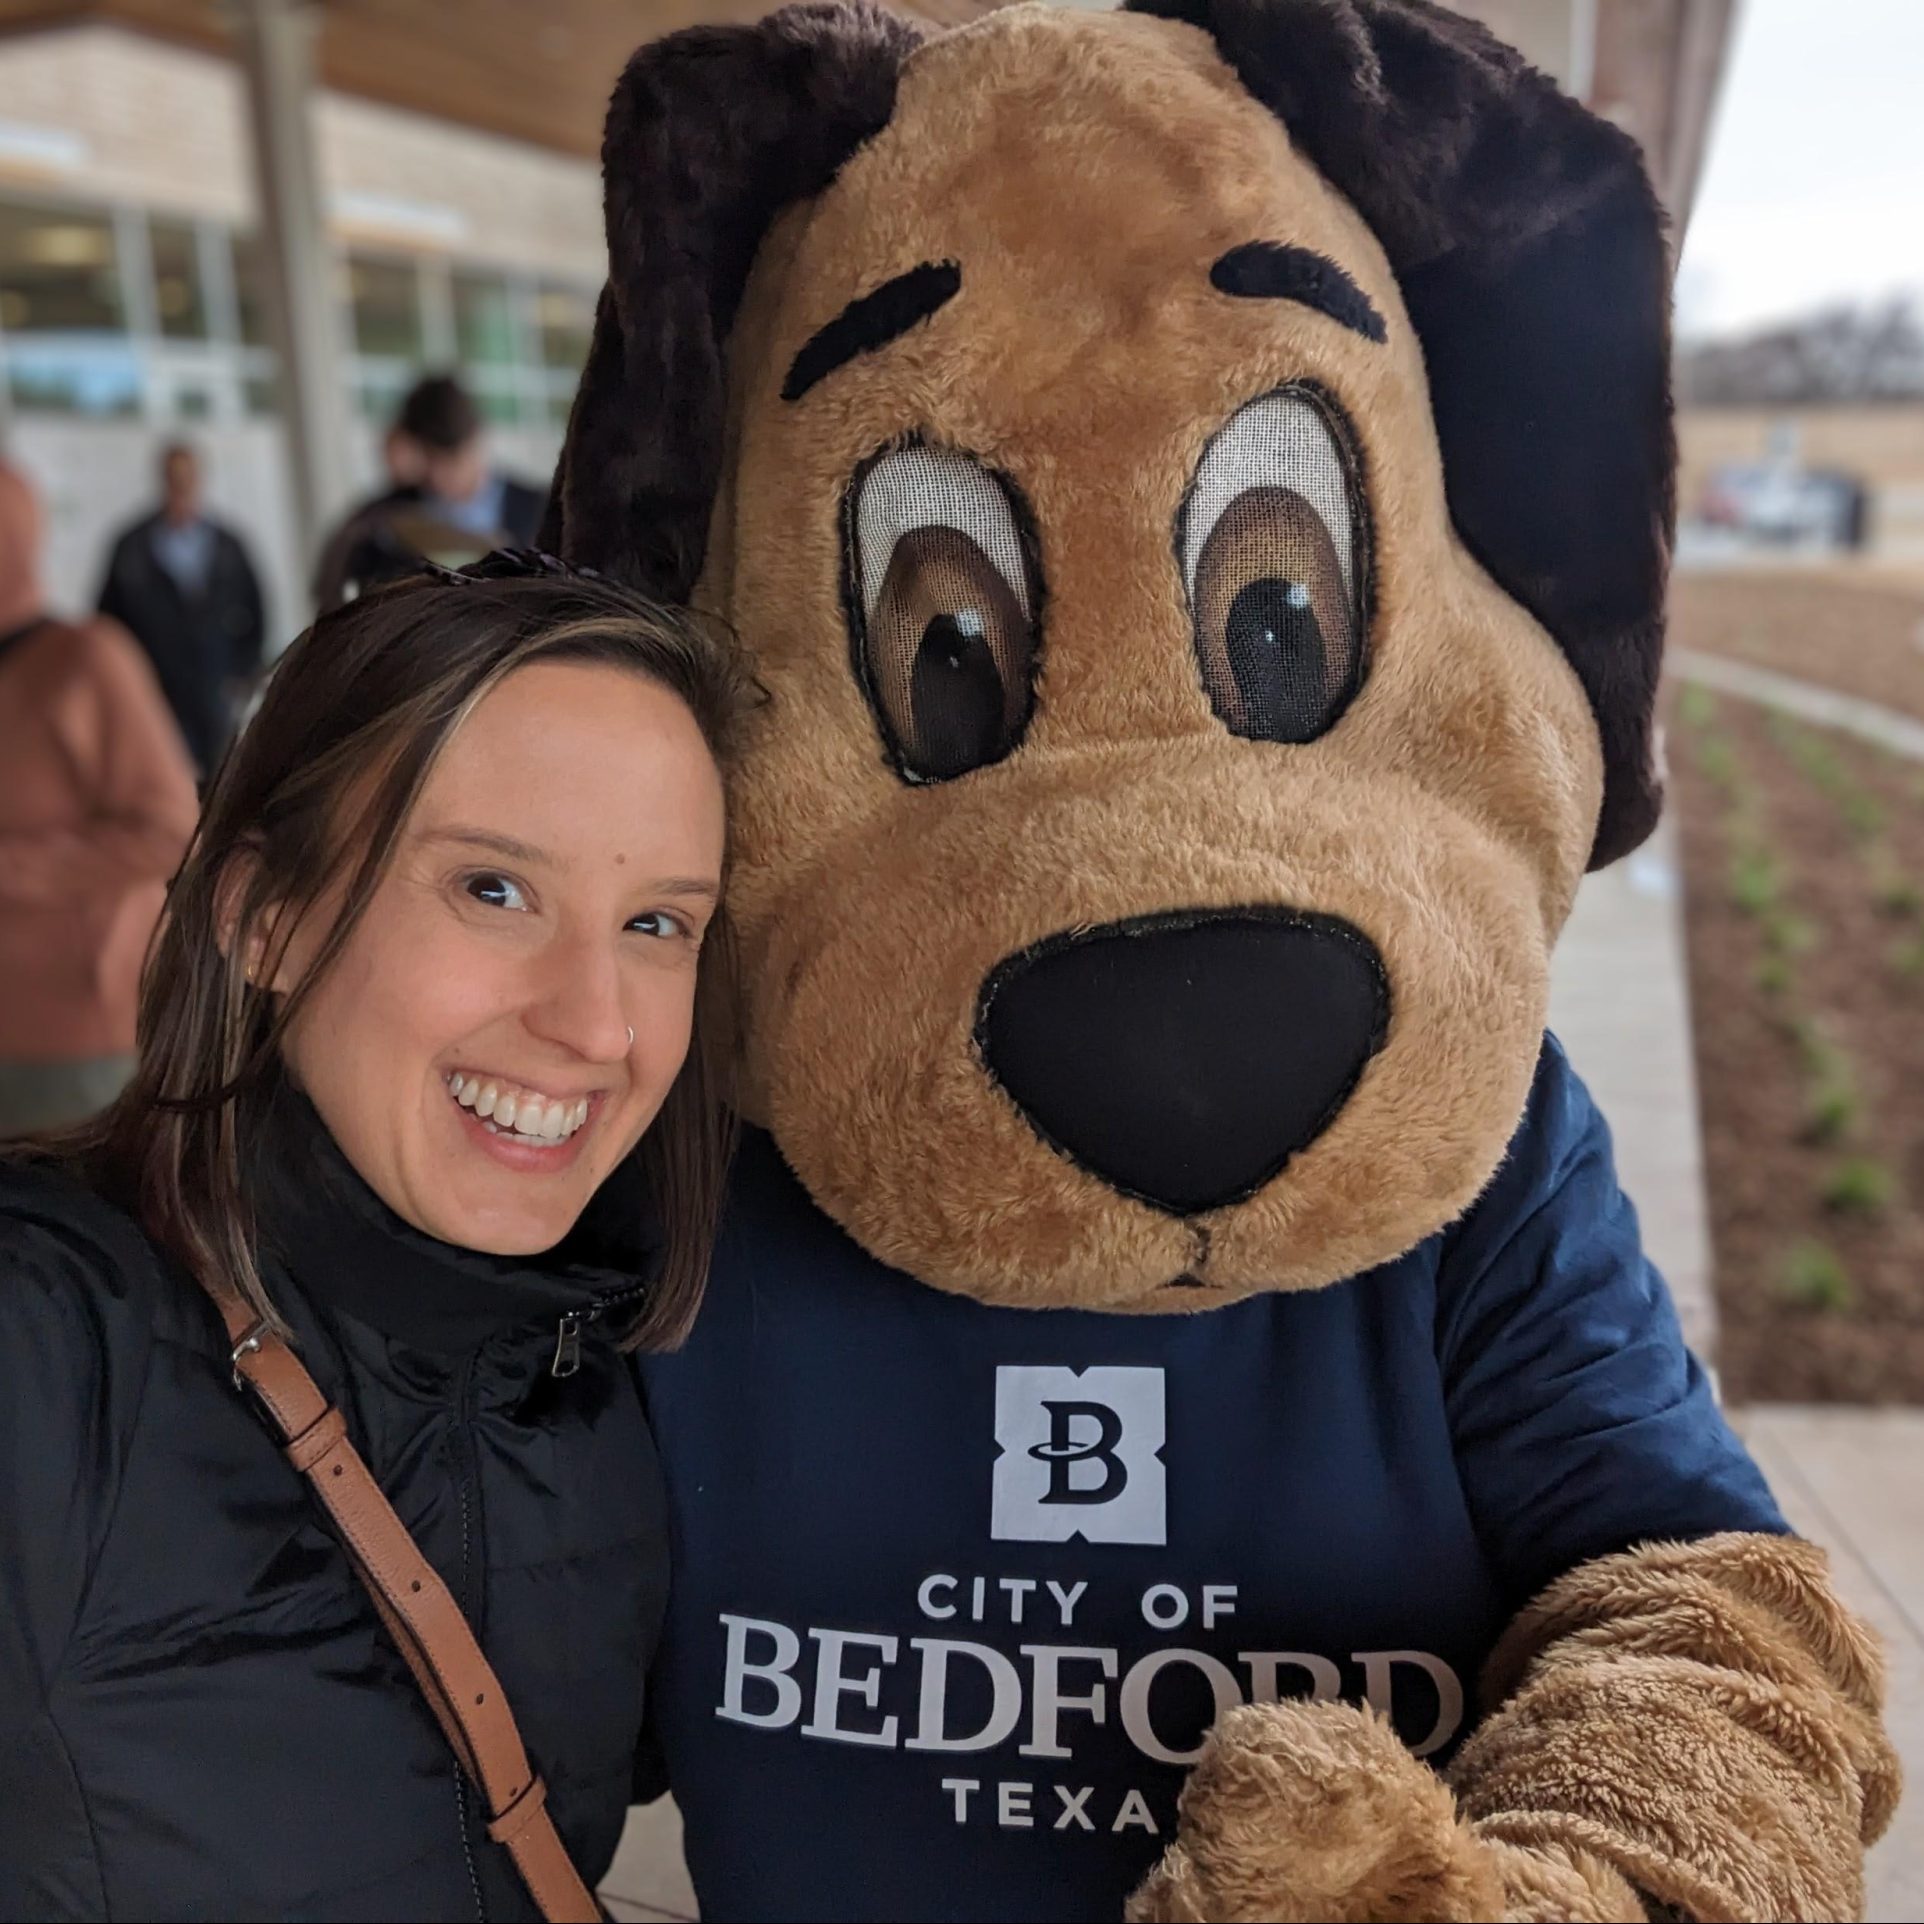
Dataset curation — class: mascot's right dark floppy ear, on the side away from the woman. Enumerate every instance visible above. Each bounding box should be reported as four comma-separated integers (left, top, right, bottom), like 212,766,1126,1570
1129,0,1676,868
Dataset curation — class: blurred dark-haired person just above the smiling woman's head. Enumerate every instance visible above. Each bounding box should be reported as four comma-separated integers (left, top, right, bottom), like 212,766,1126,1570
314,373,548,614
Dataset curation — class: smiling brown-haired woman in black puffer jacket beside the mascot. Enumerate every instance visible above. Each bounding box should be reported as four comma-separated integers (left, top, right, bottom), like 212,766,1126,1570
0,560,743,1918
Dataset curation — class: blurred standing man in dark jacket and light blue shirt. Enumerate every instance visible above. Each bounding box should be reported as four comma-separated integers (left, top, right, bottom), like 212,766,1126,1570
100,441,267,777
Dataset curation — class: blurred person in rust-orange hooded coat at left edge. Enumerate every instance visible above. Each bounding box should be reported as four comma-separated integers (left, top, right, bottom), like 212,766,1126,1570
0,466,194,1137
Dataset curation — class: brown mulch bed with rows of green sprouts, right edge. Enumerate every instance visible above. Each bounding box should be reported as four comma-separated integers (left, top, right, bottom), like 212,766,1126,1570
1668,579,1924,1403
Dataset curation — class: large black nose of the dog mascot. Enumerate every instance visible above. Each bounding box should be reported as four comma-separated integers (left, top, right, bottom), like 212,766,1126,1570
975,910,1389,1216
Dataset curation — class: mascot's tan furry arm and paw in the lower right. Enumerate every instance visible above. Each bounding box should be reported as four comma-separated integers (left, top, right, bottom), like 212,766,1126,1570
1129,1535,1899,1920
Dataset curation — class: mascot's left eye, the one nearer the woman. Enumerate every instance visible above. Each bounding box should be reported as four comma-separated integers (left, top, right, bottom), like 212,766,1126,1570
848,446,1039,781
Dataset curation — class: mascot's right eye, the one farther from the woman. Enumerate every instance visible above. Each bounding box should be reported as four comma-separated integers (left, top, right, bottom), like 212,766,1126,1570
1181,389,1368,741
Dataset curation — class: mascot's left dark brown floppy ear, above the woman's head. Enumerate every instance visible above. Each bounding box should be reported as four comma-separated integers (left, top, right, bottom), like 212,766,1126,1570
543,6,922,600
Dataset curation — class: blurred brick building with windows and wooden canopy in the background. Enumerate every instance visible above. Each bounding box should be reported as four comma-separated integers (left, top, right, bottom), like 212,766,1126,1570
0,0,1732,643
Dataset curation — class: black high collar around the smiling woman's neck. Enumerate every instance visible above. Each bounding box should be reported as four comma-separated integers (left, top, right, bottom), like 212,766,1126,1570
254,1091,662,1356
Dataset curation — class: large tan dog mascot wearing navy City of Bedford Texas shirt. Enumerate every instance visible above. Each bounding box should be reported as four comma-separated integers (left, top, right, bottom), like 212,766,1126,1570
550,0,1895,1918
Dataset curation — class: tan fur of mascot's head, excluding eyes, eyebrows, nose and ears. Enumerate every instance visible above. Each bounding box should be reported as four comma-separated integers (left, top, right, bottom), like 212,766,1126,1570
696,8,1601,1310
